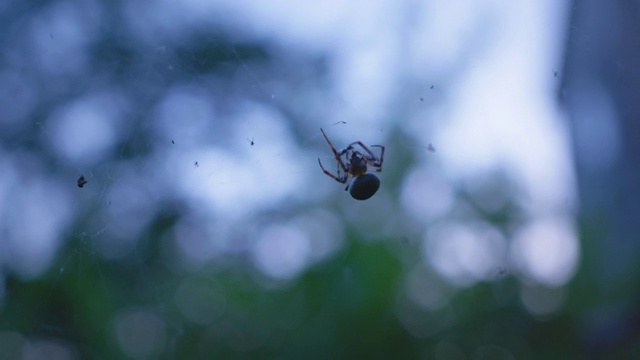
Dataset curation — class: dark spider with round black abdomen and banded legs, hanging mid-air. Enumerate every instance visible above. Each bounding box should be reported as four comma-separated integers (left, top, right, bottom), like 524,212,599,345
318,128,384,200
